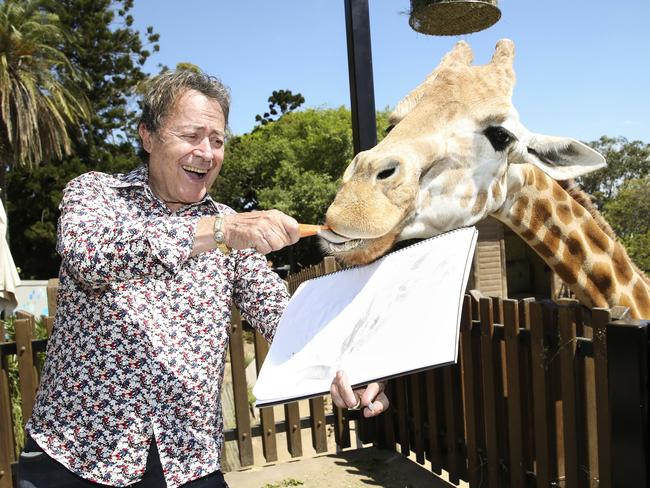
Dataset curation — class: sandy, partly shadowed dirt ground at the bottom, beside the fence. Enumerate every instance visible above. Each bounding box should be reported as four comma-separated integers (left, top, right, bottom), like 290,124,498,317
226,447,460,488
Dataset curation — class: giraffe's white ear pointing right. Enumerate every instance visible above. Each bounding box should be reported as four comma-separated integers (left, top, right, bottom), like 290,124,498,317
521,134,607,180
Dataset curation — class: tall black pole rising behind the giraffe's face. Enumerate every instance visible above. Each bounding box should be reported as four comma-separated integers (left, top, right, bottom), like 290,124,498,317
344,0,377,154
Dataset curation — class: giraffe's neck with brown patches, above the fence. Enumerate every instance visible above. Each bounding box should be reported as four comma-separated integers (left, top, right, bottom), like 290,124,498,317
493,165,650,318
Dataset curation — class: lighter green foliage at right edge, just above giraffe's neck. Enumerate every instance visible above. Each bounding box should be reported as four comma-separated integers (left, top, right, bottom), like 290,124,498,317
604,176,650,273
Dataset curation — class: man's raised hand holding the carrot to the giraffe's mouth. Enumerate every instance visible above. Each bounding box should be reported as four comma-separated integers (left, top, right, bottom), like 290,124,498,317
223,210,300,254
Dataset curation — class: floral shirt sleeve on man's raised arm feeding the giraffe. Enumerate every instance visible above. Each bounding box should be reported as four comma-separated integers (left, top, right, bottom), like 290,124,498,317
57,173,199,288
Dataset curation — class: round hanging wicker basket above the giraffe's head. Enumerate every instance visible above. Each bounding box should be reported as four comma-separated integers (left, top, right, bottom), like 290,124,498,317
409,0,501,36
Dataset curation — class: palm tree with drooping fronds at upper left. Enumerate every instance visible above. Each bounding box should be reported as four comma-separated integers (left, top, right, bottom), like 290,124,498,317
0,0,89,200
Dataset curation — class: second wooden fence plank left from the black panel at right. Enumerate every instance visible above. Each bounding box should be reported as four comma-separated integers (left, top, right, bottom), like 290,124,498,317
558,305,589,488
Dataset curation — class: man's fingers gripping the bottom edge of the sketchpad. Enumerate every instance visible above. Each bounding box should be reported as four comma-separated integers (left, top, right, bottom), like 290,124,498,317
330,371,390,417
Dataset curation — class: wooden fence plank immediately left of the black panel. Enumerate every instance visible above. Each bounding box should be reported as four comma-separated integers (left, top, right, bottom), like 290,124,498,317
591,308,612,488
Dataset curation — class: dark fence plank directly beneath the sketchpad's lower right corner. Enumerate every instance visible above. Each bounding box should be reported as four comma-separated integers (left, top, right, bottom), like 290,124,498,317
442,364,465,485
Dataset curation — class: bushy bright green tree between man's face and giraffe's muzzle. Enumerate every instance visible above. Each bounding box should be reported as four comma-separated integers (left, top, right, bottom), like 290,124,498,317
213,108,387,267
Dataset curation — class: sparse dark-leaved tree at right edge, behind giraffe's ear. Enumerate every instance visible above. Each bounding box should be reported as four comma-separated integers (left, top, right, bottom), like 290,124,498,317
579,136,650,208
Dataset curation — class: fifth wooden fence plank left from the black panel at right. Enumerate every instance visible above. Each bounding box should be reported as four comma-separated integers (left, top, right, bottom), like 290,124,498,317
480,298,501,488
